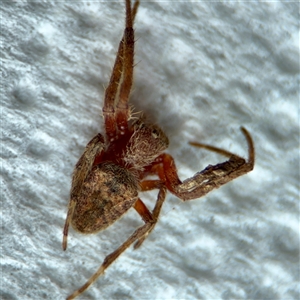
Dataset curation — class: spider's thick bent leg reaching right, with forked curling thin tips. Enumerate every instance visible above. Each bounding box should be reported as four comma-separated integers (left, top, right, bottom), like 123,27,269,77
160,127,255,201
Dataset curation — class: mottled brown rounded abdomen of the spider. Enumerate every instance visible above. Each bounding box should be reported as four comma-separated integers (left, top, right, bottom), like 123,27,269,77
71,162,138,233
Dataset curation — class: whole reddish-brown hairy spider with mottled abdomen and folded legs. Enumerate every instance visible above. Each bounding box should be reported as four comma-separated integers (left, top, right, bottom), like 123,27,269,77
62,0,255,299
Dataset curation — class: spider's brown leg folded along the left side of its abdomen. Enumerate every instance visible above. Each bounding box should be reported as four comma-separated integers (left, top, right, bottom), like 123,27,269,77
62,133,104,250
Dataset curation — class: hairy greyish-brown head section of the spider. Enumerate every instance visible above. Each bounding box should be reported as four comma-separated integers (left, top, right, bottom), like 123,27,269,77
124,117,169,170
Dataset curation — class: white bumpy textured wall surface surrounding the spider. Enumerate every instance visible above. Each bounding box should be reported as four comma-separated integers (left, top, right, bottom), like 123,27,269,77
1,1,299,300
